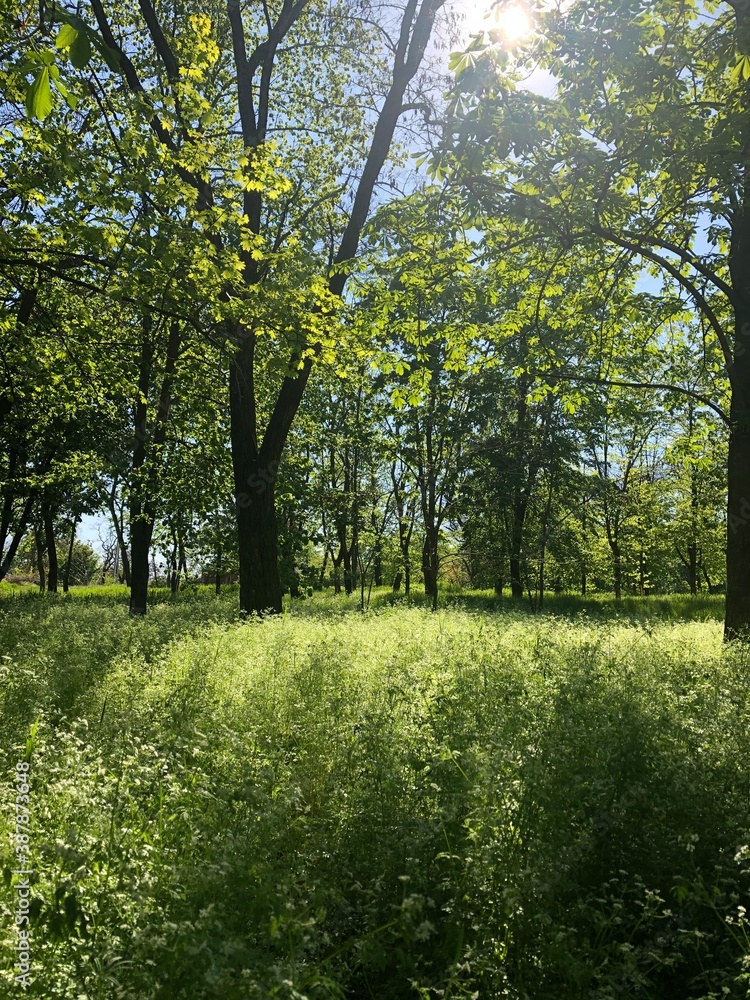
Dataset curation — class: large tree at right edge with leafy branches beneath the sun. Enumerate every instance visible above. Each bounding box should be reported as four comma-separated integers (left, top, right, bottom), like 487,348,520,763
444,0,750,638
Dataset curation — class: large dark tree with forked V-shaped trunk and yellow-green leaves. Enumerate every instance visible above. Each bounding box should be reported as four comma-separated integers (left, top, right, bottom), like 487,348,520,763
58,0,444,611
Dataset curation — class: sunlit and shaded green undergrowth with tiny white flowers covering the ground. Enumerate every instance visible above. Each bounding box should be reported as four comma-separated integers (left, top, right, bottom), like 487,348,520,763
0,588,750,1000
